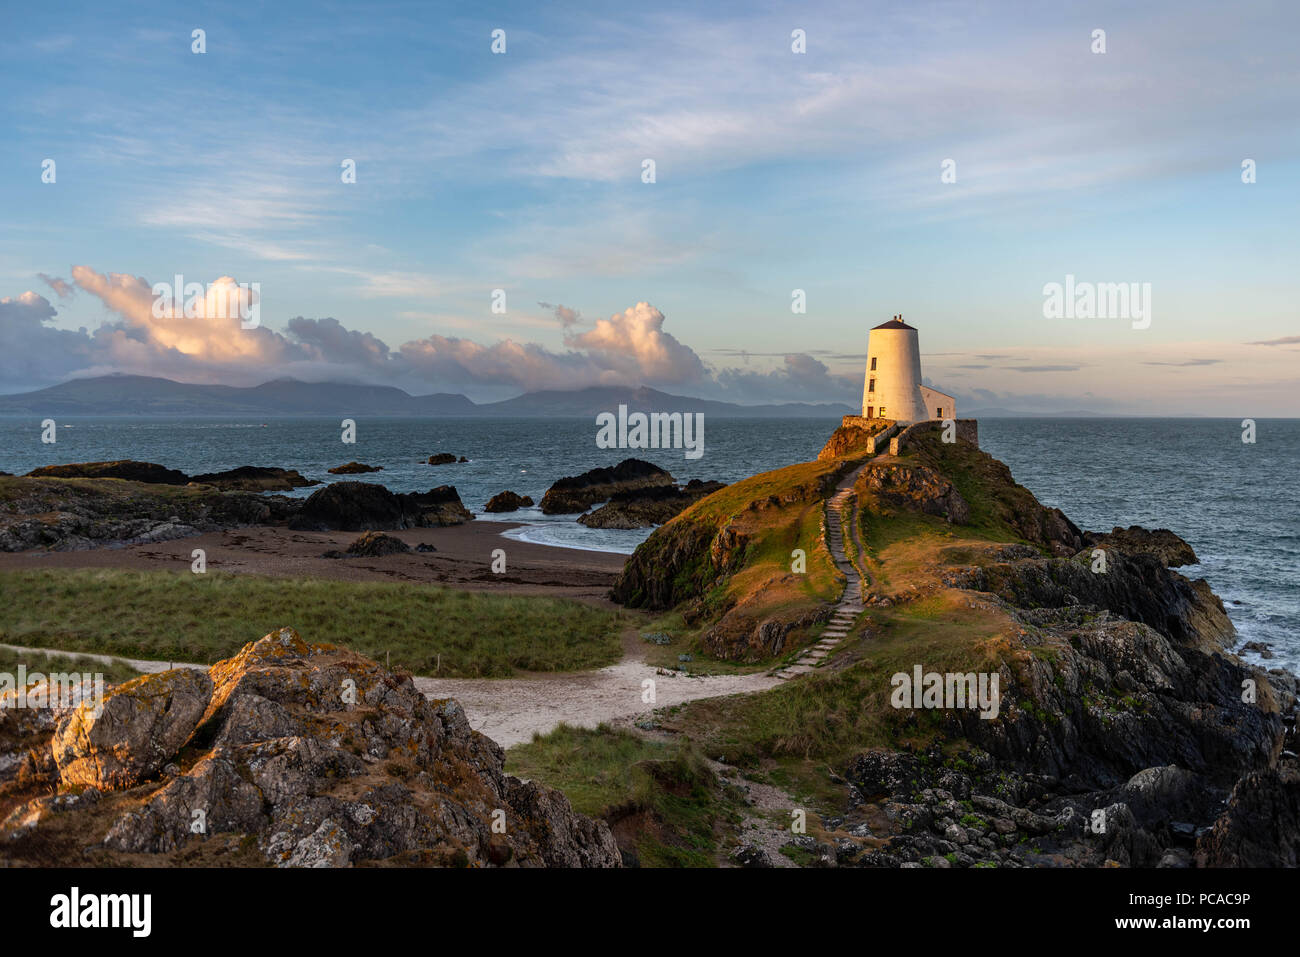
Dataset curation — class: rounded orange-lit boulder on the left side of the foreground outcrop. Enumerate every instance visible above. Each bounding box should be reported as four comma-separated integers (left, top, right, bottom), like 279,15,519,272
51,668,212,789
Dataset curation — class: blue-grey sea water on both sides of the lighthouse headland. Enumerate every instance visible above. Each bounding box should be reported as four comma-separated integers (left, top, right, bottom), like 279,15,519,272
0,416,1300,671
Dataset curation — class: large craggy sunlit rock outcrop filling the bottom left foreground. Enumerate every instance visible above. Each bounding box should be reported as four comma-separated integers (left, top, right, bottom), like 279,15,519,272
0,628,620,867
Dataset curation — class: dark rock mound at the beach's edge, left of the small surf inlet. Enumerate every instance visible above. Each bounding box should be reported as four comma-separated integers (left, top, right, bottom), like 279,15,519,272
289,482,473,532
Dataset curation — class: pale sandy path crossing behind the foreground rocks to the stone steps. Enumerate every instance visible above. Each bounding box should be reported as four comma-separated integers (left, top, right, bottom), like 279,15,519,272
0,645,781,748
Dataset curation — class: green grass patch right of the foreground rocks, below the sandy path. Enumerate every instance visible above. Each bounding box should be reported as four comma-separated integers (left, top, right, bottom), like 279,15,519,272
506,724,738,867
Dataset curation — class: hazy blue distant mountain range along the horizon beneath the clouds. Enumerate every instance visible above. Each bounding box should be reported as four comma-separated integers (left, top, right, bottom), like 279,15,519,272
0,374,855,419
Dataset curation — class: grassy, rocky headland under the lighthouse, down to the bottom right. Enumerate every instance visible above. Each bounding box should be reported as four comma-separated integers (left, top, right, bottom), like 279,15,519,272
614,428,1300,867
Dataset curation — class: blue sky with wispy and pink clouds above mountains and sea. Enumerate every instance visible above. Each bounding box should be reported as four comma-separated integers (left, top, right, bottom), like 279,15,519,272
0,3,1300,416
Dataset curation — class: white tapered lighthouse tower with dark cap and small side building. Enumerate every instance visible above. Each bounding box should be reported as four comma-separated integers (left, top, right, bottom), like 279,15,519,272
862,315,957,423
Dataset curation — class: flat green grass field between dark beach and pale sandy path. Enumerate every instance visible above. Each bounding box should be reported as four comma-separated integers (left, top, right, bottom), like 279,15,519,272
0,568,624,677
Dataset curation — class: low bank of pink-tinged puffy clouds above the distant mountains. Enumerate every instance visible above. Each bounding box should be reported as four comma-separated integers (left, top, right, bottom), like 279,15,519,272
0,265,854,402
